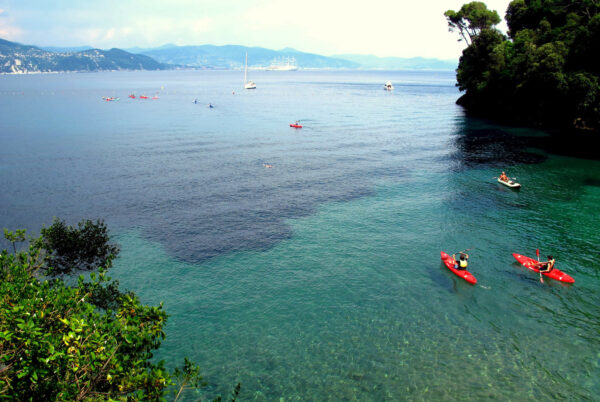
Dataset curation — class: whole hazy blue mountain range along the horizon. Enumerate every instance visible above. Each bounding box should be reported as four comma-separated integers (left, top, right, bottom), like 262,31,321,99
0,39,457,73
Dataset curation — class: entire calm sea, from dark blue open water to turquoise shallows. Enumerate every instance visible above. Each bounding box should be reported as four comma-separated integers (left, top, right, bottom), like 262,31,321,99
0,71,600,401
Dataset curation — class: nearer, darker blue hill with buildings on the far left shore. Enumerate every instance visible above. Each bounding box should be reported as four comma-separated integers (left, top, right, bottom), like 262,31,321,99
0,39,169,74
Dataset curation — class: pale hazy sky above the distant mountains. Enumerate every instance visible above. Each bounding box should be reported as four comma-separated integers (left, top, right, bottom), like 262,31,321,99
0,0,510,59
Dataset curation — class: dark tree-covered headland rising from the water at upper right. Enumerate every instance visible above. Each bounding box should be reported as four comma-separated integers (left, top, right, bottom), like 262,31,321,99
445,0,600,129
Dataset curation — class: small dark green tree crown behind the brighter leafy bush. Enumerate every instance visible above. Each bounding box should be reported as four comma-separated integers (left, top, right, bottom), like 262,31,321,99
41,218,119,275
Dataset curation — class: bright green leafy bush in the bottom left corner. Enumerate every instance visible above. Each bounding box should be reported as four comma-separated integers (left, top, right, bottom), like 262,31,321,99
0,224,239,401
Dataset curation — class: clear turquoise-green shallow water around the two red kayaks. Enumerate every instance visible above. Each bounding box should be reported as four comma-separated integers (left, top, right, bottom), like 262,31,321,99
110,160,600,400
